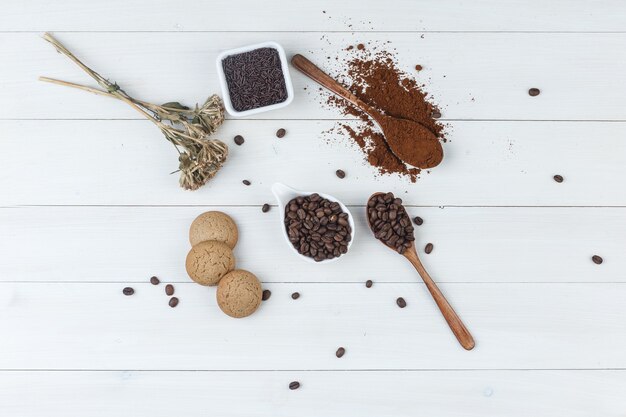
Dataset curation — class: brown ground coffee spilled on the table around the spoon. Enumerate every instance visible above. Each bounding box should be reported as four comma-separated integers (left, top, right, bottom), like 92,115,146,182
326,47,446,182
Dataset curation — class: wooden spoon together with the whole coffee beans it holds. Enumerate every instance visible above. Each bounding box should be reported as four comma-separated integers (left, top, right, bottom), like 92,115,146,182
366,193,475,350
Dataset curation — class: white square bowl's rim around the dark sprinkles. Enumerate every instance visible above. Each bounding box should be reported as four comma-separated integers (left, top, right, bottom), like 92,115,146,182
216,41,293,117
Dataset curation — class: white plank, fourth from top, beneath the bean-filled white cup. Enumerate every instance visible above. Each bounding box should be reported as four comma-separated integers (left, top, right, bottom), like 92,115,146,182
0,206,626,283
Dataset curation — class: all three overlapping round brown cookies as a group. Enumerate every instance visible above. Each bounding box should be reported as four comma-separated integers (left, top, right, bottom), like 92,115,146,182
185,211,263,318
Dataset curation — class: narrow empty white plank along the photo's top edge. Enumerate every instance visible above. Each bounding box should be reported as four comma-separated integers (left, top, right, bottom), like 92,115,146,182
0,0,626,32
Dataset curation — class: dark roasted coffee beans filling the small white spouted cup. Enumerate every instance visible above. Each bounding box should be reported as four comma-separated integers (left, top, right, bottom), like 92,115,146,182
285,194,352,262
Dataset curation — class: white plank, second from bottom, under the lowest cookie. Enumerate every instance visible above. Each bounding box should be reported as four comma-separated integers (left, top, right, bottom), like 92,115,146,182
0,280,626,370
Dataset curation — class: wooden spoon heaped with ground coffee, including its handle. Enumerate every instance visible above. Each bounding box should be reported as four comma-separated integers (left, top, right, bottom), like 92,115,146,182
291,54,443,168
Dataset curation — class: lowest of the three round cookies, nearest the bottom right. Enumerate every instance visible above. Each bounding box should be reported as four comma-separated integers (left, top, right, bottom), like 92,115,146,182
216,269,263,318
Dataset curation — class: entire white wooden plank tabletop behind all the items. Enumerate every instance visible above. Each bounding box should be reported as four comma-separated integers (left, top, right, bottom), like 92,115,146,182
0,0,626,417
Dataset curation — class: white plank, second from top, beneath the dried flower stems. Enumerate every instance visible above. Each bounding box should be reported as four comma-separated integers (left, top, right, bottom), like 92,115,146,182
0,32,626,120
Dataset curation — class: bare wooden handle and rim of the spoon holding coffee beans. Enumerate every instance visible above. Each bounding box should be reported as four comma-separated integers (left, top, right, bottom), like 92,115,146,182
365,193,475,350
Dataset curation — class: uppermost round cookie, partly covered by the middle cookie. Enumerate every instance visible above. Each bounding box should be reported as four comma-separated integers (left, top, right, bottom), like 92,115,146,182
189,211,239,249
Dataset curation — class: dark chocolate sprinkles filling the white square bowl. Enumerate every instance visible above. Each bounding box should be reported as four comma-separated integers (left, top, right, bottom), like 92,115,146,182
222,48,287,111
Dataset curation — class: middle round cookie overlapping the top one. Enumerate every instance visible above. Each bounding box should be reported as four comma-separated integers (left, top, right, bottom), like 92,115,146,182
185,240,235,285
